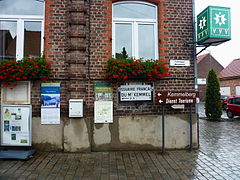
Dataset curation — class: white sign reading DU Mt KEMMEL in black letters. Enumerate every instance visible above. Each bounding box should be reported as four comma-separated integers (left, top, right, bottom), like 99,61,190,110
118,83,153,102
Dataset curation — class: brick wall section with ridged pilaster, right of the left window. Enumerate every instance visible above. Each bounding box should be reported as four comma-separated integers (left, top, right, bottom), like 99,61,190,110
41,0,89,116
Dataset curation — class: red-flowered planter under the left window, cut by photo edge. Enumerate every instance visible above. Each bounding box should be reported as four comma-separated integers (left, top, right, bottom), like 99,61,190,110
0,58,51,87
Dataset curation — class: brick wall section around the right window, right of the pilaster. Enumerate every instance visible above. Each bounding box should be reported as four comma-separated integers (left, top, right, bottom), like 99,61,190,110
90,0,194,115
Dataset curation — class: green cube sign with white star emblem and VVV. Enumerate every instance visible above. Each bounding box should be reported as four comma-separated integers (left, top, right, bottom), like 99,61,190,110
197,6,231,45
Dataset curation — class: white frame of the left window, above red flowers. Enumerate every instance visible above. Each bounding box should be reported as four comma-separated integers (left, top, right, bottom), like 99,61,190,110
0,14,45,60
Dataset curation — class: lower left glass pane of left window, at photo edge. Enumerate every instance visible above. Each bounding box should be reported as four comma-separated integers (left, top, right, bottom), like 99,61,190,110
0,21,17,60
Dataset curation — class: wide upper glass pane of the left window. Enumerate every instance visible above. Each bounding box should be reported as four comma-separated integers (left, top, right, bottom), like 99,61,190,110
0,0,44,15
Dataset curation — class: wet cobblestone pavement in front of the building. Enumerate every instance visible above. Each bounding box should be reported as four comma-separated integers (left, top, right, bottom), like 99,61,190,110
0,120,240,180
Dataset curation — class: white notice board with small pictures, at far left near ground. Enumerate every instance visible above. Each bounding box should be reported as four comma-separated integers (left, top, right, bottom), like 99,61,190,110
1,105,32,146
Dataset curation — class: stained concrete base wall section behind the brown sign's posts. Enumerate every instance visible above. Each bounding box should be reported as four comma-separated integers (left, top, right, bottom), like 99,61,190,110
92,114,198,151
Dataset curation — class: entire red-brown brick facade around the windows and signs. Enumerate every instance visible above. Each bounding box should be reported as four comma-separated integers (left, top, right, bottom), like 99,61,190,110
39,0,194,115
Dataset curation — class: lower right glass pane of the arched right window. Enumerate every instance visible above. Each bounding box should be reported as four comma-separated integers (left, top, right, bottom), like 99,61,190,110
138,24,155,59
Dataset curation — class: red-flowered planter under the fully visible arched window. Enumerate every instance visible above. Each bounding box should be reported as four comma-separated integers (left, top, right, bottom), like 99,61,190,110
106,58,169,83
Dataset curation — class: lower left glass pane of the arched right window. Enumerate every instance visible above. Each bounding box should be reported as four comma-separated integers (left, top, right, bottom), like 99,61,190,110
115,24,132,59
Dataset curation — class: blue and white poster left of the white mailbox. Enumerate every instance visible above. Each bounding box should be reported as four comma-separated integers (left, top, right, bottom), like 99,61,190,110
41,83,60,124
